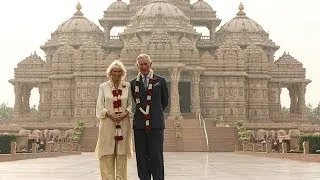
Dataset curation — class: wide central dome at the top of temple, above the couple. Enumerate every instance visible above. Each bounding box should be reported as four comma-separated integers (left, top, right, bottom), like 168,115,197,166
136,0,189,20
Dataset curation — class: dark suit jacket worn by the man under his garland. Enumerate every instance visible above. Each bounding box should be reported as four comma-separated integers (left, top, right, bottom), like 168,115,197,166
130,74,169,129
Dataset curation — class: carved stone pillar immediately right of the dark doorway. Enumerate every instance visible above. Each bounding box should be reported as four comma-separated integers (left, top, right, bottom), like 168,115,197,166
191,71,201,113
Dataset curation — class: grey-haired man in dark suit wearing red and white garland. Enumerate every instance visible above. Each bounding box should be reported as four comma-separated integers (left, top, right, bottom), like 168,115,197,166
130,54,168,180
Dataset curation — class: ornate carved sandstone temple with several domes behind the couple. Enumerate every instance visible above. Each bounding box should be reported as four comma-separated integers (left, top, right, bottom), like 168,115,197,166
9,0,311,129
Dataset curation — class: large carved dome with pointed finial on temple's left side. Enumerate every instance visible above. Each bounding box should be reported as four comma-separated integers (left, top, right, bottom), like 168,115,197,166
41,3,104,49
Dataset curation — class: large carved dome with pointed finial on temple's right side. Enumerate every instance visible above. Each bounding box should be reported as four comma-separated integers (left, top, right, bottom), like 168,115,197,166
219,4,266,33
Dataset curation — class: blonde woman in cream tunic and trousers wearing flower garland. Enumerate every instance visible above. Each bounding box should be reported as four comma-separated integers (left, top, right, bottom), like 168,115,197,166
95,60,132,180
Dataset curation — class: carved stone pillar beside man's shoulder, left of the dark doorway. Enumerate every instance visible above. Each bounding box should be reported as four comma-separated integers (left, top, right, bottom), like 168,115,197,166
169,67,182,116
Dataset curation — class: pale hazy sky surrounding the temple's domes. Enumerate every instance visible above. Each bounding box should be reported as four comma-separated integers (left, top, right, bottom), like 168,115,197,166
0,0,320,107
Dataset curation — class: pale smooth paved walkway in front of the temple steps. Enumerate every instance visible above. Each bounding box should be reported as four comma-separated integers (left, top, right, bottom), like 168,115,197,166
0,152,320,180
